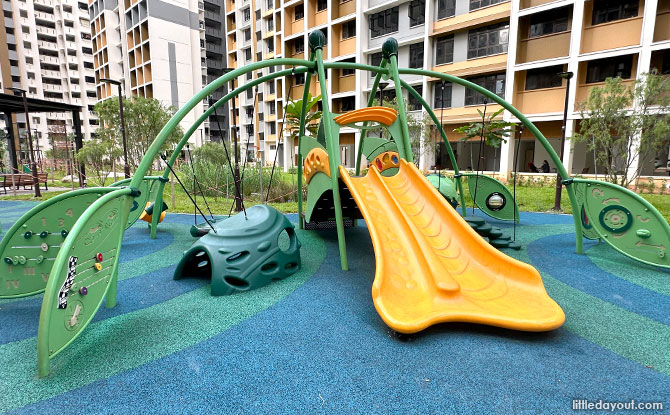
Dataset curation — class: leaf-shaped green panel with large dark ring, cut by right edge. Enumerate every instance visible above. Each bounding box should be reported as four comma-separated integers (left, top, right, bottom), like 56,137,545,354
575,179,670,268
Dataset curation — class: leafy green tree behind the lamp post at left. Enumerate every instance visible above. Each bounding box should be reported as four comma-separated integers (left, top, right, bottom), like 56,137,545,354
94,96,184,172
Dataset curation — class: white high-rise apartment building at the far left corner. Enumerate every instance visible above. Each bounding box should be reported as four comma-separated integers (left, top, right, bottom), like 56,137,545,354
0,0,98,154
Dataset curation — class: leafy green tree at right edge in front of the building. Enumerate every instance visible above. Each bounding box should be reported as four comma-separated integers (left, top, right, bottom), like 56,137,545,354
572,72,670,187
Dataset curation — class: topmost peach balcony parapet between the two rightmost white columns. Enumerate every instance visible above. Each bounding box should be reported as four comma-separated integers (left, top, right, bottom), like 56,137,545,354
581,13,642,53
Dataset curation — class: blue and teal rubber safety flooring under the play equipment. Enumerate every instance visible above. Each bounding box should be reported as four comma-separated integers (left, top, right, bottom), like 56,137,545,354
0,202,670,414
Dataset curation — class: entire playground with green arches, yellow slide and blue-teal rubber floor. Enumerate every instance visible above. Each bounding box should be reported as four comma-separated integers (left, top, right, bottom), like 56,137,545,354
0,31,670,414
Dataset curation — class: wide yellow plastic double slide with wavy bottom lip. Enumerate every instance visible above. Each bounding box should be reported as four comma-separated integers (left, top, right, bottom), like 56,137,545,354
340,160,565,333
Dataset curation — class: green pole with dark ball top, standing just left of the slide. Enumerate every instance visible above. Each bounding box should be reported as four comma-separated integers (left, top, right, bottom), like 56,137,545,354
309,30,349,271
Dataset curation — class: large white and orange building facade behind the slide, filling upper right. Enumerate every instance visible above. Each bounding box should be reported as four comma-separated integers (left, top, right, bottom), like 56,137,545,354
225,0,670,177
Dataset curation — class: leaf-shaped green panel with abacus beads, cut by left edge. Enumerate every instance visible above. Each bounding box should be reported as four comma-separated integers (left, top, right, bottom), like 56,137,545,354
0,187,114,298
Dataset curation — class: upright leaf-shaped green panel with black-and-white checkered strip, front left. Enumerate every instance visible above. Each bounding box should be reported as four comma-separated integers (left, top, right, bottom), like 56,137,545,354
37,188,132,376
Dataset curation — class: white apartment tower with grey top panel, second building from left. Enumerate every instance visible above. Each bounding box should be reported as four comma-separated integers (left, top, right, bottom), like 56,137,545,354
88,0,228,145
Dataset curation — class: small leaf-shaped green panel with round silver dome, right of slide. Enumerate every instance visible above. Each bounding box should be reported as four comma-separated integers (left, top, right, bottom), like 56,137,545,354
463,173,519,222
